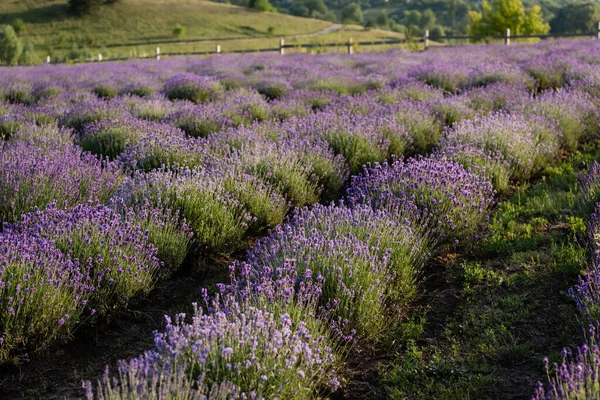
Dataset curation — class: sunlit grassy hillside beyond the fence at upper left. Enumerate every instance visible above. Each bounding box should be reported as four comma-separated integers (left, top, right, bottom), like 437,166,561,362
0,0,331,54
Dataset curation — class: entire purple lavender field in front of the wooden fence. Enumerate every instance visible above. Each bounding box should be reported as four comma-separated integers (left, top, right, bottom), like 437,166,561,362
0,40,600,400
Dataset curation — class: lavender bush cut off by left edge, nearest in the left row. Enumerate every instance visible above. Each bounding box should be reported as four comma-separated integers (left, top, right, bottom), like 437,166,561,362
0,232,90,363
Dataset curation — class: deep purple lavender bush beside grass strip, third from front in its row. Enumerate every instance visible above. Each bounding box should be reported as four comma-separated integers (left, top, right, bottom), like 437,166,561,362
348,158,494,244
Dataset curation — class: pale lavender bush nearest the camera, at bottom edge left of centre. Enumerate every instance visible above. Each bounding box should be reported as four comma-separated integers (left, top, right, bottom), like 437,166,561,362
86,301,338,400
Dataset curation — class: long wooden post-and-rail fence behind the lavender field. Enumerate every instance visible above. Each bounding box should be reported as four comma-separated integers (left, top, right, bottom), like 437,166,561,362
46,22,600,63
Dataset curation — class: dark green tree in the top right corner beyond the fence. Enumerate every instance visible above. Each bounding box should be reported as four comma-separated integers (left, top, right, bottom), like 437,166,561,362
550,3,600,33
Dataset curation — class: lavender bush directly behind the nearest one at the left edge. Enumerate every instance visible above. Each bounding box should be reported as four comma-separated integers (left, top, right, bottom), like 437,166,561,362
4,202,162,314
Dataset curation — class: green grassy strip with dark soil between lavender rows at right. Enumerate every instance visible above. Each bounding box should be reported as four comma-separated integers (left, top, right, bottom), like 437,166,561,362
380,149,599,400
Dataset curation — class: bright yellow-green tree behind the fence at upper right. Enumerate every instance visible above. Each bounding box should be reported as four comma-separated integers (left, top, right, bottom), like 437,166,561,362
469,0,550,36
